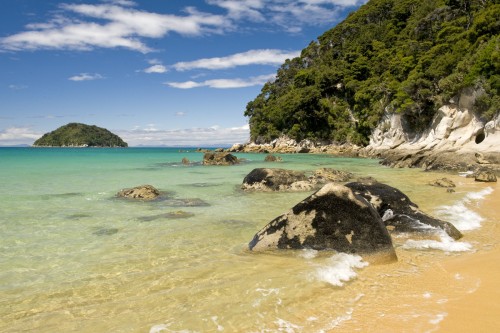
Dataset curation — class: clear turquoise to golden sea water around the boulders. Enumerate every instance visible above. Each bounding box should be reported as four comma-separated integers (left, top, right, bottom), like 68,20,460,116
0,148,494,333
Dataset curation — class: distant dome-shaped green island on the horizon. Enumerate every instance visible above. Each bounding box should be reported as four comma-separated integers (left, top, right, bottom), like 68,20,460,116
33,123,128,147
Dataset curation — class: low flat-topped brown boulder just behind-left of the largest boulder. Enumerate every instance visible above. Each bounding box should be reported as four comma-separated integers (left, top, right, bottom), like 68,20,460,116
241,168,313,191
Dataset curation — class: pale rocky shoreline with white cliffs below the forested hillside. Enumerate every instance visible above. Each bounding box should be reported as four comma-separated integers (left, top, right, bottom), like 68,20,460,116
227,99,500,176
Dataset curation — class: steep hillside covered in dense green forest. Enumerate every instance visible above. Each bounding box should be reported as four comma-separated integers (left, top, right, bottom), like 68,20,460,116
245,0,500,144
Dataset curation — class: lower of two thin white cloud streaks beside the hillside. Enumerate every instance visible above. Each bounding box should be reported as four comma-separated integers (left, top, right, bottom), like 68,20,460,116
165,74,275,89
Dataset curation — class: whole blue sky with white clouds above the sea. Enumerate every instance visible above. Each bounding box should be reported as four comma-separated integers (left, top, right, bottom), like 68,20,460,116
0,0,366,146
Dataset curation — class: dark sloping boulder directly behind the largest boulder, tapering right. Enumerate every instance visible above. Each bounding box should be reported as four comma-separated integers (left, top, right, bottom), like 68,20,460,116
346,182,462,239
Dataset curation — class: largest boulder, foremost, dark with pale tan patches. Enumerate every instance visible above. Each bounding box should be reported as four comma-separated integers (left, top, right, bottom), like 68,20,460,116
249,183,397,260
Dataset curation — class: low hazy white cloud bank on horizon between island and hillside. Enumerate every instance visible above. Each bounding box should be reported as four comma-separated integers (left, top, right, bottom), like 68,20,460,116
119,124,250,147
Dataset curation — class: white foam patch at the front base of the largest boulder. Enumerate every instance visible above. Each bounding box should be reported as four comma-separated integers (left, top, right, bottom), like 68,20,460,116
316,253,368,287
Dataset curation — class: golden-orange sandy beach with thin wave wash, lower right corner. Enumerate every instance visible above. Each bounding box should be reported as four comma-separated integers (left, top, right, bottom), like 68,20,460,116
327,177,500,333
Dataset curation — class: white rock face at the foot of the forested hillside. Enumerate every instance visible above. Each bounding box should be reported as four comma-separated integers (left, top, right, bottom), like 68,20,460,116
368,94,500,153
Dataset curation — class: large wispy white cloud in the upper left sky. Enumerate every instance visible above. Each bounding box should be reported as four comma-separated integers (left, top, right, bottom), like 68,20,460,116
0,0,229,53
